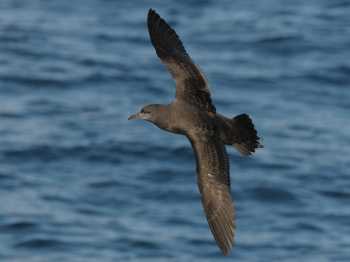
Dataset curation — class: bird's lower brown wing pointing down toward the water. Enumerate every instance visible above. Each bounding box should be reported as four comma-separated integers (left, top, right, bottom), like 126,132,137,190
190,136,235,255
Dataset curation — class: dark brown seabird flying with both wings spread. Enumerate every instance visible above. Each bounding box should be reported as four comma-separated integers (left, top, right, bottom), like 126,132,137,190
129,9,262,255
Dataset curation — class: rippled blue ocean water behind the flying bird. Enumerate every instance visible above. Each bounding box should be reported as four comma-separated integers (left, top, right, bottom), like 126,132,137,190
0,0,350,262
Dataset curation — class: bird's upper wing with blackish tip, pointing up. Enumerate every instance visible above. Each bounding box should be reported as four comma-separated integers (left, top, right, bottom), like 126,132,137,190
147,9,216,113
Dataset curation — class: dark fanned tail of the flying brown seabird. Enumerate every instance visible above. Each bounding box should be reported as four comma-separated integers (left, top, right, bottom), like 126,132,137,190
231,114,263,155
